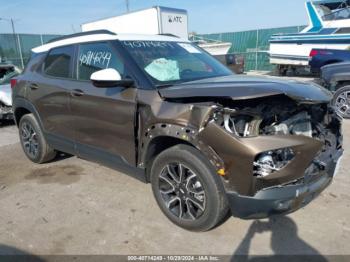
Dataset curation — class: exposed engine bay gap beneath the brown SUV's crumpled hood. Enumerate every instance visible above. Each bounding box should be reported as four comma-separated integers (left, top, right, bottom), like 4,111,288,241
215,96,327,137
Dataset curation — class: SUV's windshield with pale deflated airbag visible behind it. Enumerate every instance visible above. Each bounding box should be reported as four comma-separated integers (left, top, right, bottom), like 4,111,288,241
122,41,233,86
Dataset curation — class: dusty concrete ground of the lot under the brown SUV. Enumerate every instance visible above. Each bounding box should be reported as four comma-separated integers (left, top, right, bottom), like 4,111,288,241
0,119,350,255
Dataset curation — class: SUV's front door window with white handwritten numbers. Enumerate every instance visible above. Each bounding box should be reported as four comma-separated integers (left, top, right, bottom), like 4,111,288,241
77,43,124,80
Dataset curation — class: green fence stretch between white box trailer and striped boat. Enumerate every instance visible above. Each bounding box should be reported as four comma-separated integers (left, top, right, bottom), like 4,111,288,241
196,26,305,71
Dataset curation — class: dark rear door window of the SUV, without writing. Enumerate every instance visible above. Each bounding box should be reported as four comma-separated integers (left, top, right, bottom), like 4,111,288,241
44,46,74,78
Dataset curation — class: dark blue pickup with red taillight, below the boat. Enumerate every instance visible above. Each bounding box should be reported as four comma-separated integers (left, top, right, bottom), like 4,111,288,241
309,49,350,75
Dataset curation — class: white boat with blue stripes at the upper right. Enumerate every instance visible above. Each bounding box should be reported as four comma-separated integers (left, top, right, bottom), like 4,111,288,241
270,0,350,69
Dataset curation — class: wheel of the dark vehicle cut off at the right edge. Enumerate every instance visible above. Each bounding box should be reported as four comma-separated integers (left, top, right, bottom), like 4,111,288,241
332,85,350,119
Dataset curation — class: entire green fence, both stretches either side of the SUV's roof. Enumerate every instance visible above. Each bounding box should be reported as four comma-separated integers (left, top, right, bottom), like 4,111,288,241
0,26,304,71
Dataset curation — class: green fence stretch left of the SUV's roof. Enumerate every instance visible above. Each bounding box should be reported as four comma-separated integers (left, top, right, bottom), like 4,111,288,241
0,34,59,68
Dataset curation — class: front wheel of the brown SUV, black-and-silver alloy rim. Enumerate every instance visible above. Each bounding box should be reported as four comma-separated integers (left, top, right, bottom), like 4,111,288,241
151,145,229,232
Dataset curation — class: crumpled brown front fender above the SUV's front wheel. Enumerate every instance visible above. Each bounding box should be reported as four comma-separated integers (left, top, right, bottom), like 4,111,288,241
137,90,224,172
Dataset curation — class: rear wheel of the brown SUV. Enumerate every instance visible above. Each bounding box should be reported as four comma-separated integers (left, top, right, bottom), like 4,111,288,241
19,114,56,164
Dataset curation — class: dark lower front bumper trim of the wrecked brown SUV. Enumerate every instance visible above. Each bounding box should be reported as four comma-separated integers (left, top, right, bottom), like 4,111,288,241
227,149,343,219
